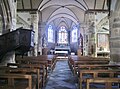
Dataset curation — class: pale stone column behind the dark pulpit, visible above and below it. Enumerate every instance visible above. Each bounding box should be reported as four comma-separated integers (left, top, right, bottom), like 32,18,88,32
1,0,17,65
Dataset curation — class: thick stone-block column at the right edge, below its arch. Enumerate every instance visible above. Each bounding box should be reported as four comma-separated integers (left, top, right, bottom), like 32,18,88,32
110,11,120,64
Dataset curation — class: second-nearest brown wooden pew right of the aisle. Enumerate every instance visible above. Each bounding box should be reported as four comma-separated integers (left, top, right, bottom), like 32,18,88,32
79,69,120,89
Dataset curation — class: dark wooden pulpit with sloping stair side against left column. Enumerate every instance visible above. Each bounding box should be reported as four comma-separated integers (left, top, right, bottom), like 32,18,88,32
0,28,34,61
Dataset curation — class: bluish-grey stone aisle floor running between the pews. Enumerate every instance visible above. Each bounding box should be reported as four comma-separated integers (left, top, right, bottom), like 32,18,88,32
45,60,77,89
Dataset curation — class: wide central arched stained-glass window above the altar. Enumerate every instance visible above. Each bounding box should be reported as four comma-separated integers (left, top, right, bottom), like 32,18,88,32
58,26,68,44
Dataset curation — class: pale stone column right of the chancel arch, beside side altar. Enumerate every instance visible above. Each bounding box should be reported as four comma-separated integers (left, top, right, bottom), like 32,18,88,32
85,13,97,57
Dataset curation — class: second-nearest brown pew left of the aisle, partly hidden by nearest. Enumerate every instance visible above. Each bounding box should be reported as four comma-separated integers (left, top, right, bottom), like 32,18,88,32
0,66,42,89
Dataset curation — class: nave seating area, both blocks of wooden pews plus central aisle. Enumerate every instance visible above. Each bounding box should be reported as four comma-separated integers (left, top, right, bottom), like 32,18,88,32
0,55,120,89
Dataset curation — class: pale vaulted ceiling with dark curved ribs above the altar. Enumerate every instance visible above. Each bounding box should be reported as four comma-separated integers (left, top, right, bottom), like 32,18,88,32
17,0,110,29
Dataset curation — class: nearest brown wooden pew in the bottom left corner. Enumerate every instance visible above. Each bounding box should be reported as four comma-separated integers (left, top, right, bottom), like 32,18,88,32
0,73,32,89
